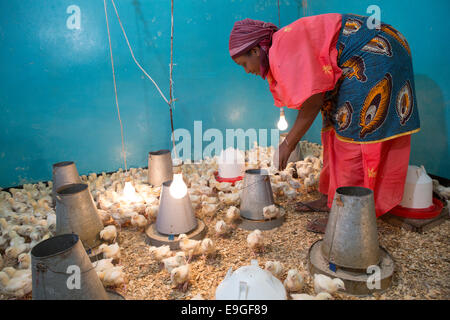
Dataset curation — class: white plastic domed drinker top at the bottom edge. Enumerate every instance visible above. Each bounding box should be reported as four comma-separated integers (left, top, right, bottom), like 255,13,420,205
216,260,287,300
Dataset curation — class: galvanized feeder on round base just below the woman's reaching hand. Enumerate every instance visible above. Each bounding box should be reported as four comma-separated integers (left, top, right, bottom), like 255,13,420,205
239,169,284,230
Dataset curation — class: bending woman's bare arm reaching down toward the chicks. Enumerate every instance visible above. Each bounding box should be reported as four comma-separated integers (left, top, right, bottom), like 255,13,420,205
278,93,324,170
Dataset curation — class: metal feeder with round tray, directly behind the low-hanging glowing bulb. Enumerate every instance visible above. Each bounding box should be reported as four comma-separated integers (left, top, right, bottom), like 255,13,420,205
145,181,207,250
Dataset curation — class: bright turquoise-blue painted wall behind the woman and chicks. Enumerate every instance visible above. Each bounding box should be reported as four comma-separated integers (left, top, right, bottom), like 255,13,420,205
0,0,450,187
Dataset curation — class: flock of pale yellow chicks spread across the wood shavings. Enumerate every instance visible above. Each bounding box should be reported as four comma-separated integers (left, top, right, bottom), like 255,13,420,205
0,141,448,299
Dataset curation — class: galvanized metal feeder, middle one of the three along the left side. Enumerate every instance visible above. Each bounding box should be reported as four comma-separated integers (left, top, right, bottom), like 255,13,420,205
56,183,103,249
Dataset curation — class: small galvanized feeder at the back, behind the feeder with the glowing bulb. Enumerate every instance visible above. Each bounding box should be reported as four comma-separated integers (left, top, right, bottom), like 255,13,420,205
148,150,173,186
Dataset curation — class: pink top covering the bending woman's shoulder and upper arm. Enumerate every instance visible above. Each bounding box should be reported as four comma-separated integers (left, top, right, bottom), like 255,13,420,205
267,13,342,109
